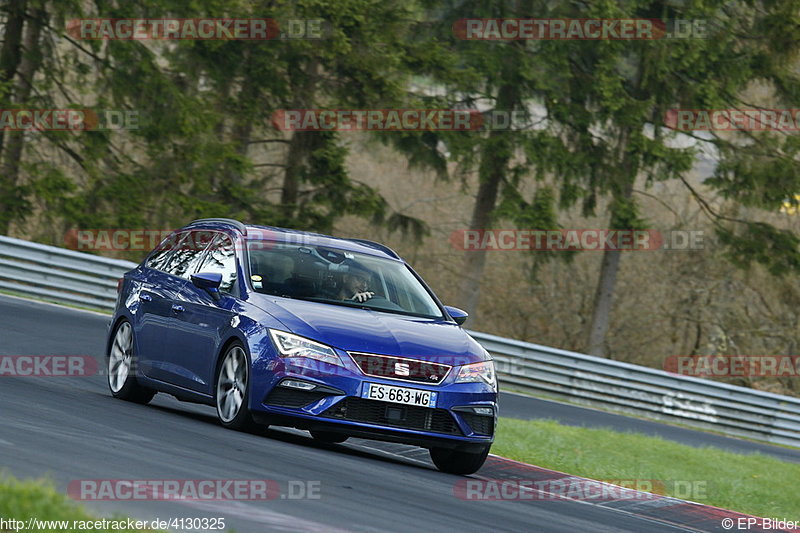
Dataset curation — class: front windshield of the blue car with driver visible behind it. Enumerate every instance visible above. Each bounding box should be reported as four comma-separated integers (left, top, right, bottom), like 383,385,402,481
247,239,443,318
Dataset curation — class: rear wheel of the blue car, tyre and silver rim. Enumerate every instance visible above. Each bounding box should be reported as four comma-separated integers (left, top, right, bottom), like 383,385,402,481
106,320,156,405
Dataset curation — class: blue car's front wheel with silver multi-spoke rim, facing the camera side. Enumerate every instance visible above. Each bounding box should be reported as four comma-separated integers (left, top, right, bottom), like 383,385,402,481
214,342,264,432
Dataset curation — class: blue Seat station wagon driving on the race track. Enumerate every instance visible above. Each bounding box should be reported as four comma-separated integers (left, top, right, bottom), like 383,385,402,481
107,219,497,474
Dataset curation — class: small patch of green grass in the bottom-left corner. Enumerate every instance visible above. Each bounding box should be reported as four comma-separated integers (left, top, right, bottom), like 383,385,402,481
0,476,161,533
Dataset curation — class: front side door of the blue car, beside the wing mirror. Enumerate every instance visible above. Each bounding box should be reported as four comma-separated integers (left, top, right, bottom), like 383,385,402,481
164,233,238,394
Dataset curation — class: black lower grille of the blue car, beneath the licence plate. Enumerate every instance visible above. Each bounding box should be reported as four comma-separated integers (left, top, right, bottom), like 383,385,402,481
322,396,462,435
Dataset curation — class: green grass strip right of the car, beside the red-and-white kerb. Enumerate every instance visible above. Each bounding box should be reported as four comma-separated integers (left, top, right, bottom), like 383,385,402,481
492,418,800,520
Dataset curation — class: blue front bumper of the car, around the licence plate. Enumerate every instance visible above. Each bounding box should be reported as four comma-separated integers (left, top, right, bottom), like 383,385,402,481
250,358,497,451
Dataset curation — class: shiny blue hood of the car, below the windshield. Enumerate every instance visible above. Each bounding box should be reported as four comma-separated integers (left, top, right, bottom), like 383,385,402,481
252,294,488,365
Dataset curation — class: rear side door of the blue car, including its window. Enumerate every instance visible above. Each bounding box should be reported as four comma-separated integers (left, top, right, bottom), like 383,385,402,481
145,230,210,386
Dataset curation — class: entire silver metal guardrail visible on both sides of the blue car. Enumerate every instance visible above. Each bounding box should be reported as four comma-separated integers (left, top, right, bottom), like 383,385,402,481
0,236,800,446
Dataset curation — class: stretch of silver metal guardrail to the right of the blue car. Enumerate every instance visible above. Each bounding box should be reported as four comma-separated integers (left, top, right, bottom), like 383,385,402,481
469,331,800,446
